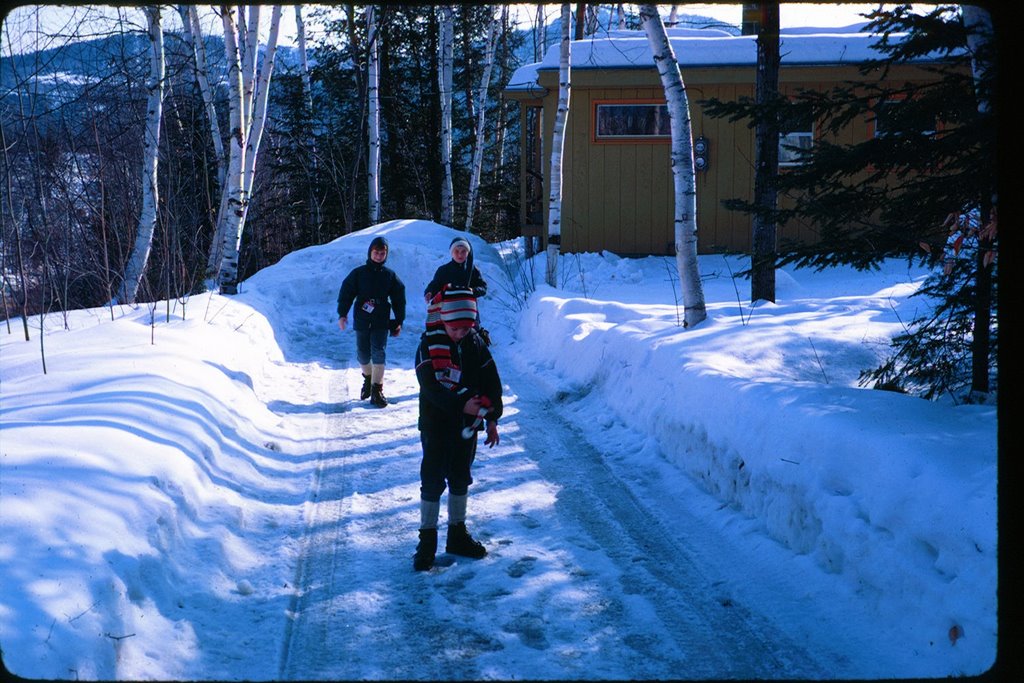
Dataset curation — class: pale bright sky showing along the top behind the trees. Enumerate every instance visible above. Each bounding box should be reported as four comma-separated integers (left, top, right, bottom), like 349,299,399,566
3,3,913,53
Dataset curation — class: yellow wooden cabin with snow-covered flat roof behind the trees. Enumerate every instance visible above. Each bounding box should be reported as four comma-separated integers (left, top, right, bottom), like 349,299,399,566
505,29,966,255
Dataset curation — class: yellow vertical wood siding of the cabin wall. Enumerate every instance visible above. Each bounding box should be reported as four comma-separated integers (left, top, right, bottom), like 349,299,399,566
509,59,954,255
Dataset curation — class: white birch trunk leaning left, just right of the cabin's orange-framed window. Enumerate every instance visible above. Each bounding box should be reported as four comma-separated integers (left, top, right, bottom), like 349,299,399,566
639,5,708,328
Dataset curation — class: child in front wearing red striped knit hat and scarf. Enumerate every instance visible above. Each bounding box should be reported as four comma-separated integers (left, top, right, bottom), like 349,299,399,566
413,287,503,571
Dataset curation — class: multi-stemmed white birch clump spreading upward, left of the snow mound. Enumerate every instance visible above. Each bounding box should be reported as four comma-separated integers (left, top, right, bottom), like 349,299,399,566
214,5,282,294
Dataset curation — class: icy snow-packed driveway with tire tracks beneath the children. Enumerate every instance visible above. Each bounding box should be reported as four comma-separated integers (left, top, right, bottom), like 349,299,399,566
266,321,843,680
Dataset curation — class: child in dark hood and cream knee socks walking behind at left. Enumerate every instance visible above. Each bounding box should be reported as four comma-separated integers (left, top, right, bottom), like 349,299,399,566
338,236,406,408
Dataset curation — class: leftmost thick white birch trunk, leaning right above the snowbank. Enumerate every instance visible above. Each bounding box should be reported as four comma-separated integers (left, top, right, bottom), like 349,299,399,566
119,5,164,303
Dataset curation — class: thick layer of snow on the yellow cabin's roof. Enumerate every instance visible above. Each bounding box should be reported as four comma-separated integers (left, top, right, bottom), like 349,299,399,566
506,25,958,91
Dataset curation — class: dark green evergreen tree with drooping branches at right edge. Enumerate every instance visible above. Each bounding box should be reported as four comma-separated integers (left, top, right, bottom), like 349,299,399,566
705,5,997,398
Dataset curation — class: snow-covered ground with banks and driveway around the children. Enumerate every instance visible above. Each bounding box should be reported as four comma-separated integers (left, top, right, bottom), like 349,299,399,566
0,221,1001,680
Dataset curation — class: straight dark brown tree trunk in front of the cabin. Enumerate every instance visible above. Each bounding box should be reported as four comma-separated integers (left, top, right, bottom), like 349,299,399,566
751,0,779,303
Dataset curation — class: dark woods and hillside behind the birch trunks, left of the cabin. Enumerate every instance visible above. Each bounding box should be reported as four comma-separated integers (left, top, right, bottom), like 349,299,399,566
0,4,528,318
